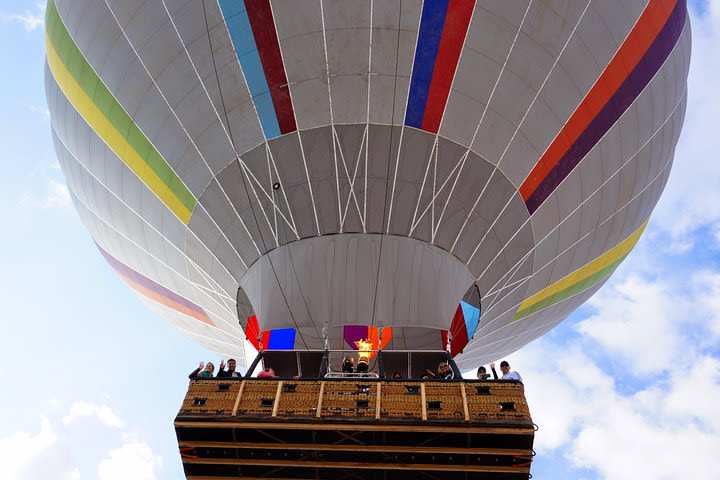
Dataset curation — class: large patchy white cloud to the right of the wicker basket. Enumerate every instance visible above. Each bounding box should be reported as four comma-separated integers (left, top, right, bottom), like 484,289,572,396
511,260,720,480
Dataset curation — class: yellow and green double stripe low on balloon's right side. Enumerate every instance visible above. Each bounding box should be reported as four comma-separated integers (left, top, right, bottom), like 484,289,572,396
512,220,647,322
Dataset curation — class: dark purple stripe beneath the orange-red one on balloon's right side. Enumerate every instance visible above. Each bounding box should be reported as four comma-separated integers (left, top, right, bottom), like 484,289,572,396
525,0,687,215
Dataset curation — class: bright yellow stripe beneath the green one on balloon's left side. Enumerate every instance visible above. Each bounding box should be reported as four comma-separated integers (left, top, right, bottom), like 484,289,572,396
45,33,191,225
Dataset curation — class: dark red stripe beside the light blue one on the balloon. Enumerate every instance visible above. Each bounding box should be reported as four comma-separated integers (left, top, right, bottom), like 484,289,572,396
245,0,297,133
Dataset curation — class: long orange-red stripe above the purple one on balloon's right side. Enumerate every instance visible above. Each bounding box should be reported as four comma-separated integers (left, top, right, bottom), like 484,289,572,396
520,0,676,201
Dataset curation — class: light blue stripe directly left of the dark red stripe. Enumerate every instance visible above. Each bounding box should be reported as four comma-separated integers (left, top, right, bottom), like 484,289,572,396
218,0,280,139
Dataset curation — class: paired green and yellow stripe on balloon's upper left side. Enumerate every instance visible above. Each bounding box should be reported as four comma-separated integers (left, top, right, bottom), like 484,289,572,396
45,0,197,225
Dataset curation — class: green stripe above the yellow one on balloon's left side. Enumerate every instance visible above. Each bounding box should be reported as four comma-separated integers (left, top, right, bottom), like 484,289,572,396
45,0,197,212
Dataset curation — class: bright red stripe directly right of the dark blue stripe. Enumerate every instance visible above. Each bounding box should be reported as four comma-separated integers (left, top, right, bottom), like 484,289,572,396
421,0,475,133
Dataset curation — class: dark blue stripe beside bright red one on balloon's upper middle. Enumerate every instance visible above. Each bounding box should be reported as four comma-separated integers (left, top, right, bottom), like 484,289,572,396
405,0,450,128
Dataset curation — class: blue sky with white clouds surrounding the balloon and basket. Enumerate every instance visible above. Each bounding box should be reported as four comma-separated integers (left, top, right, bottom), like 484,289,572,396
0,0,720,480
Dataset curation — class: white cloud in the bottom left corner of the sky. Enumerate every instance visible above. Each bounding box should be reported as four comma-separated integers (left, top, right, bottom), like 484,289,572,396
0,418,80,480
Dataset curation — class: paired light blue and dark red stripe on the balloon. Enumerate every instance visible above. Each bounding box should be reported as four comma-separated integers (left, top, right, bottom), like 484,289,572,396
219,0,297,139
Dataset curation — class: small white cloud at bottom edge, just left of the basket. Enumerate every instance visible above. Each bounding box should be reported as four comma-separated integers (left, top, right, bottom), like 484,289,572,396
98,440,163,480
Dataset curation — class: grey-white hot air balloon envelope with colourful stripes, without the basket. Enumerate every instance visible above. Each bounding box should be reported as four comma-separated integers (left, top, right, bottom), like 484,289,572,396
45,0,690,369
